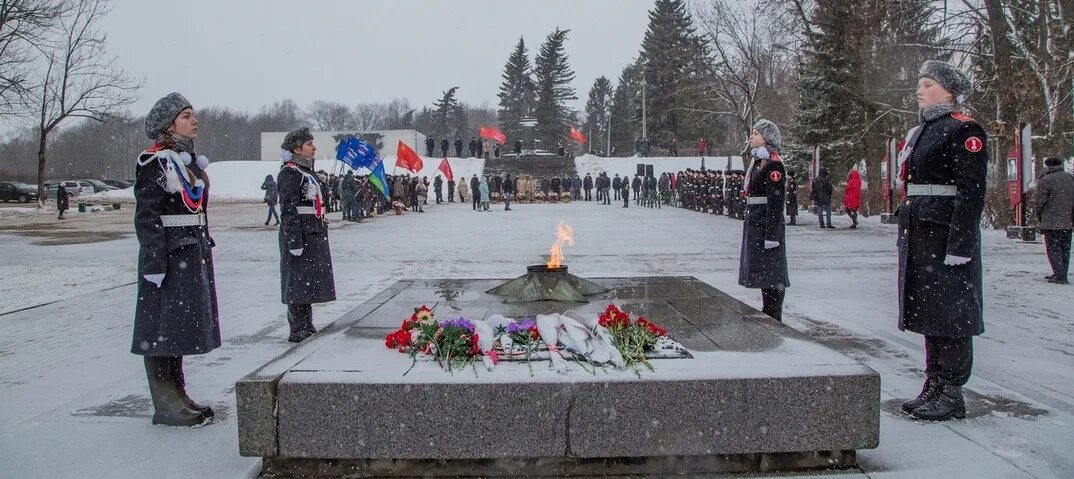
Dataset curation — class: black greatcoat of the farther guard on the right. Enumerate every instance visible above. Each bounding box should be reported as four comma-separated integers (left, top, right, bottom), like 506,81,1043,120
739,151,790,289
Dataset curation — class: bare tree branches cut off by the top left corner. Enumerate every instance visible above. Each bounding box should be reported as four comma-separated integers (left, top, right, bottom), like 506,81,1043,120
0,0,66,118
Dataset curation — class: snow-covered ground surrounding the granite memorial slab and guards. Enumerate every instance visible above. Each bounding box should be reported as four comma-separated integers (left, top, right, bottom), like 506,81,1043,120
0,197,1074,479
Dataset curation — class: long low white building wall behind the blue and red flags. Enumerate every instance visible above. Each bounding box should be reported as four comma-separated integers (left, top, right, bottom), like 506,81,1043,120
261,130,427,161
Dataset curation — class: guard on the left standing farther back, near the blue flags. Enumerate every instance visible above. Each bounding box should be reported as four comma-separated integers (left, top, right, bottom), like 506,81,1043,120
276,128,335,343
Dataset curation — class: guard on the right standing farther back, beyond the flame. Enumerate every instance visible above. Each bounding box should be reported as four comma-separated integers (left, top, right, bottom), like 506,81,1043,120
739,119,790,321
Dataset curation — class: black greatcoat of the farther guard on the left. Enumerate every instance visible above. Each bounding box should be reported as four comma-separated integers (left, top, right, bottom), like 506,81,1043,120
276,163,335,304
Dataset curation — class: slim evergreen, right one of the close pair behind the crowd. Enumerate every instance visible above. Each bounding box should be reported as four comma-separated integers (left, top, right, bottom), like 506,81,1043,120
534,28,578,150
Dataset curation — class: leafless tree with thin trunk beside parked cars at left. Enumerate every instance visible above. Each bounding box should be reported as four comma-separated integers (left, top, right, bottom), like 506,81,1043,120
32,0,142,206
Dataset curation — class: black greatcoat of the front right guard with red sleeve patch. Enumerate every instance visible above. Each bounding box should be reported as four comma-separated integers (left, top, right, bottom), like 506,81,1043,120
897,113,988,337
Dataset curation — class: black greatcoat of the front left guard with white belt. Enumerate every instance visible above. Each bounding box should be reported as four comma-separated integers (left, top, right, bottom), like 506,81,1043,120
131,148,220,357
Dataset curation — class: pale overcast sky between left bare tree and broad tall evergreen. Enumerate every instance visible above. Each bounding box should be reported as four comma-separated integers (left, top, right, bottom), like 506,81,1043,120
101,0,653,115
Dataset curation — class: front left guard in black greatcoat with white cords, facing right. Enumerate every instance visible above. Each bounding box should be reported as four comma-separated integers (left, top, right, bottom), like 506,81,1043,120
131,93,220,426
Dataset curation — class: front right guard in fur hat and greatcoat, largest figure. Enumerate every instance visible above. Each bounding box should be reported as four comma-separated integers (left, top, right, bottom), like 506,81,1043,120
896,60,988,421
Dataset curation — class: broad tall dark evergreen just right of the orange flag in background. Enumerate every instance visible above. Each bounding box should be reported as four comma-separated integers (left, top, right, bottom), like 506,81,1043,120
641,0,708,151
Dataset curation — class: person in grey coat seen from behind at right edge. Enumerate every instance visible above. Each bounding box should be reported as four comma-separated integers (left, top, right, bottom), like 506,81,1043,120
1036,158,1074,285
